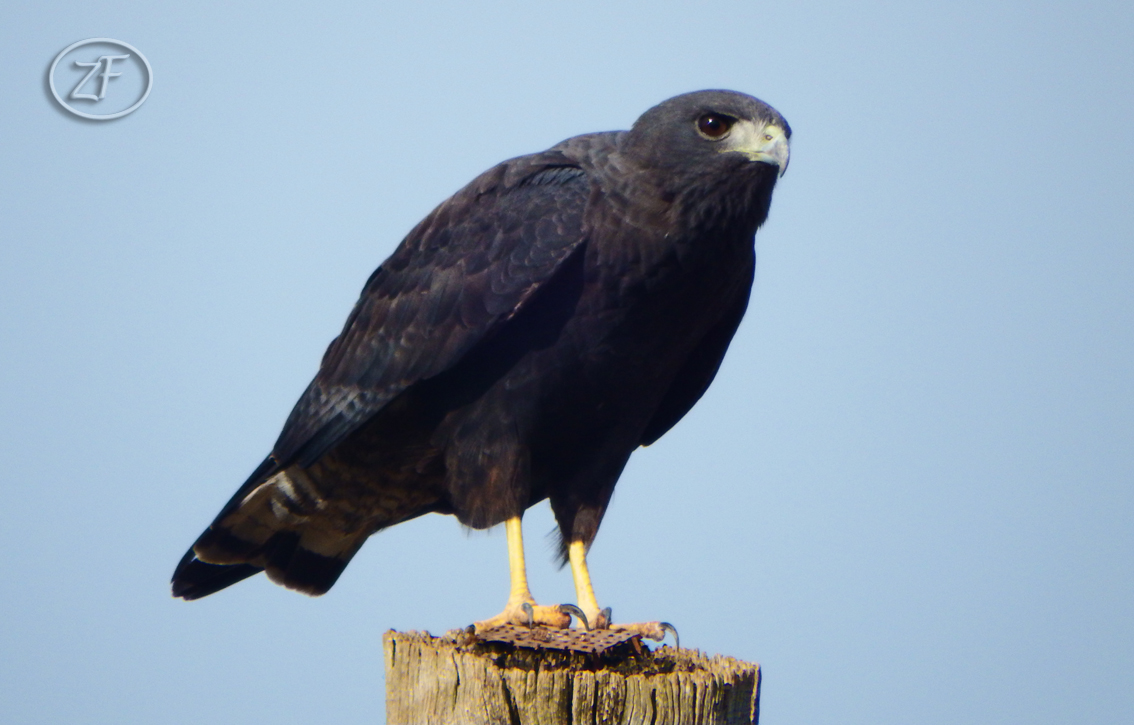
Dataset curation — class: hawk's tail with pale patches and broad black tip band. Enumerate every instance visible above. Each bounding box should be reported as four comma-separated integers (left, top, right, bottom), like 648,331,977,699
172,458,370,599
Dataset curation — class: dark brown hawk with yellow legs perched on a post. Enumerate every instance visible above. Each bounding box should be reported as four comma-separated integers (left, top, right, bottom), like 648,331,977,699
172,91,792,639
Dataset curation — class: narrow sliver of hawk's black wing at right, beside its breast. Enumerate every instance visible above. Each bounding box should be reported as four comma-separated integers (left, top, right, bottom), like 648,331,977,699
638,258,755,446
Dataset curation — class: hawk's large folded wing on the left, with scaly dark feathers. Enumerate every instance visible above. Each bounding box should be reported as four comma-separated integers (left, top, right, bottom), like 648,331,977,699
272,151,590,466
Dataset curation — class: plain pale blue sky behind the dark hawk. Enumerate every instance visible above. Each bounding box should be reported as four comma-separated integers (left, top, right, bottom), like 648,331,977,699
0,0,1134,725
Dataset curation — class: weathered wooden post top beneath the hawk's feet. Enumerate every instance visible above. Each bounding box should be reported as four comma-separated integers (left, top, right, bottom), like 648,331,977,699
382,627,760,725
